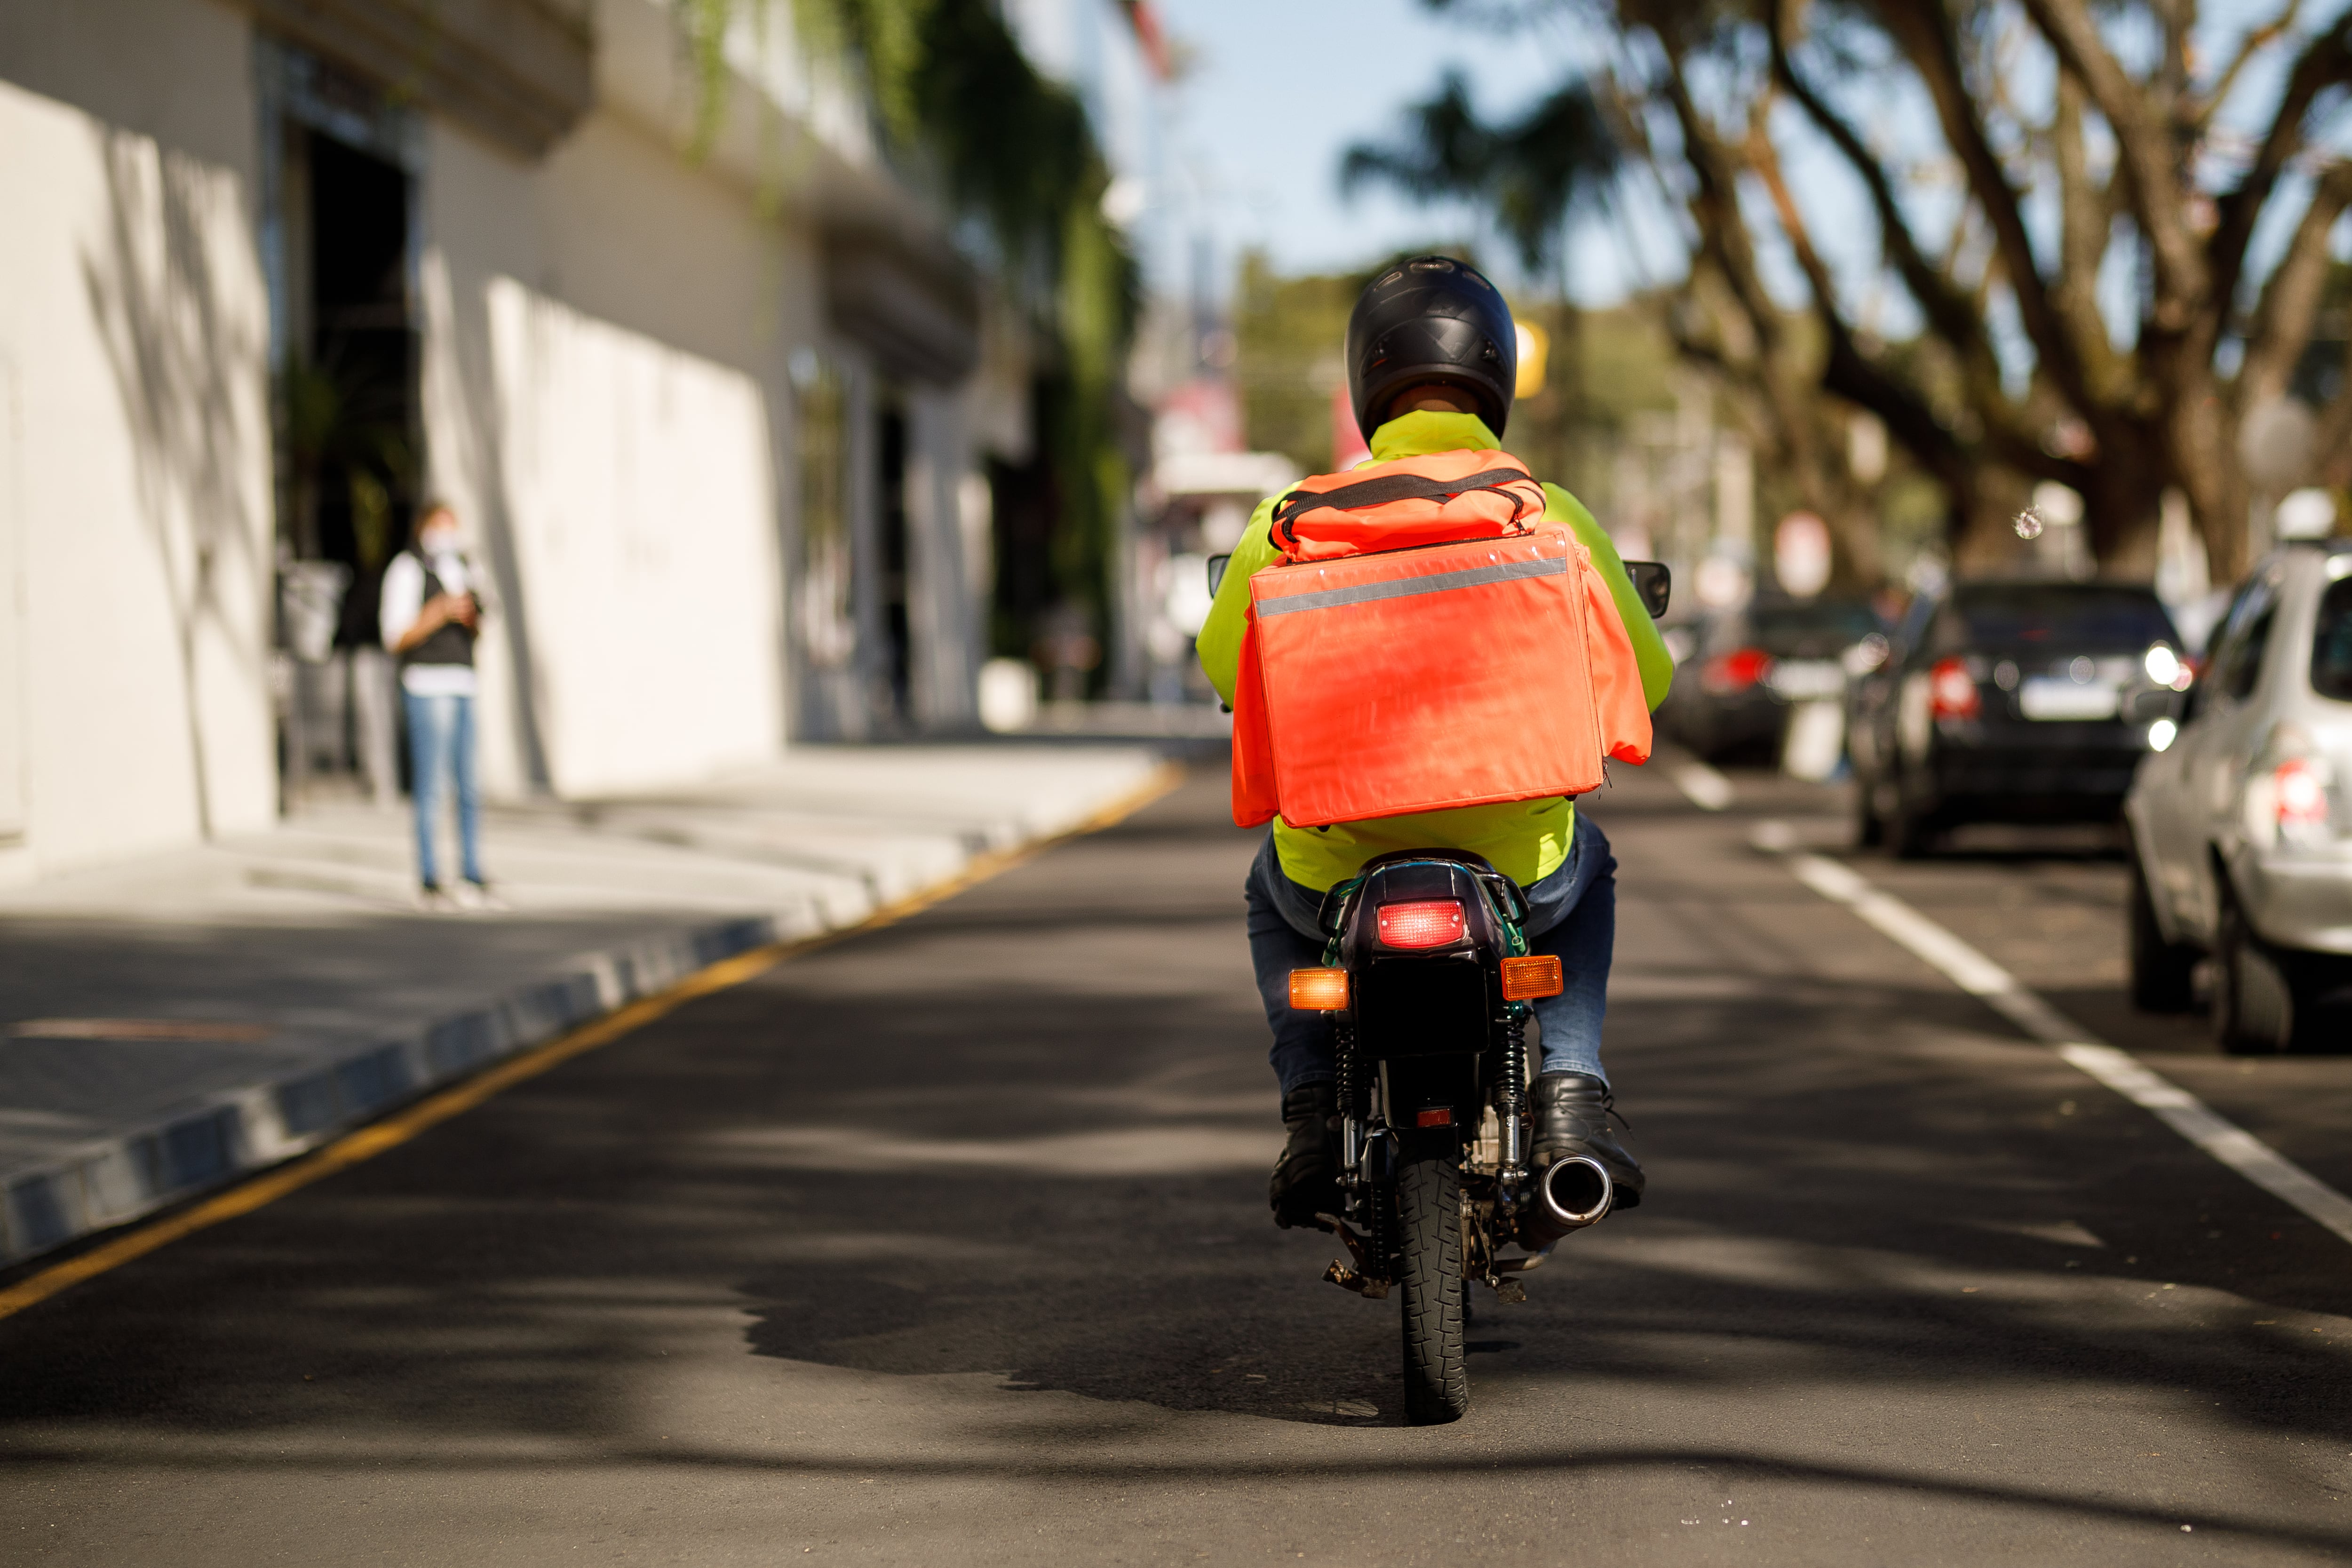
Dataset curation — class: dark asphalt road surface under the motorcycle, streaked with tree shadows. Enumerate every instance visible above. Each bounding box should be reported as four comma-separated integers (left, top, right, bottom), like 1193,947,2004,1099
0,771,2352,1566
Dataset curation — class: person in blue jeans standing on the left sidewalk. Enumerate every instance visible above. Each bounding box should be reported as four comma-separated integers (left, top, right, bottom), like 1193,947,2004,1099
381,501,496,910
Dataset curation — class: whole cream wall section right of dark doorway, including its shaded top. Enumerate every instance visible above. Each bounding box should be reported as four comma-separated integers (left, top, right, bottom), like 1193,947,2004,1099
423,108,837,795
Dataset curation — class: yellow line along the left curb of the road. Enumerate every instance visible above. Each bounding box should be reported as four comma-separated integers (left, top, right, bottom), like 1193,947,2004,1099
0,762,1183,1319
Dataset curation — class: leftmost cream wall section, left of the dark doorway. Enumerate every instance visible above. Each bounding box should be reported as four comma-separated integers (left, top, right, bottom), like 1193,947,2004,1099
0,0,278,879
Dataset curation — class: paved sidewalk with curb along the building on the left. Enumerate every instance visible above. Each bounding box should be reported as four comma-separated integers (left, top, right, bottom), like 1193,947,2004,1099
0,740,1167,1265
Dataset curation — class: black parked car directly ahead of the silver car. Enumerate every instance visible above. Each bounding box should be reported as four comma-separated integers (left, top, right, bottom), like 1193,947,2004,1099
1846,583,2190,856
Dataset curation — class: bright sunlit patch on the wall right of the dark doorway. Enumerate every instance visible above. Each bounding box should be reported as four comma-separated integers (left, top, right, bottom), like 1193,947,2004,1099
489,278,783,795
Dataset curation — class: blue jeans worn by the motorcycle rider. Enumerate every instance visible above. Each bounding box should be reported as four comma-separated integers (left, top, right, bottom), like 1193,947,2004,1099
1242,811,1616,1093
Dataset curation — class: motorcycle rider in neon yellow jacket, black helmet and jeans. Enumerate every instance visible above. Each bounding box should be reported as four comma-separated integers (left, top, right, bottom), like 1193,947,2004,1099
1200,256,1675,1239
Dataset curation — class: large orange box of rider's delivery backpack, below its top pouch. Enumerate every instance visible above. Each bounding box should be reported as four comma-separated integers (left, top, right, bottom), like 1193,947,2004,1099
1232,526,1649,828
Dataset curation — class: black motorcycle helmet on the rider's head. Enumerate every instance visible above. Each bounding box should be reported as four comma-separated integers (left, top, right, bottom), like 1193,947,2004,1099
1348,256,1519,437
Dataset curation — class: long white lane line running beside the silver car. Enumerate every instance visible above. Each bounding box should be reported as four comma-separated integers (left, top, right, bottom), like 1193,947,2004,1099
1750,823,2352,1241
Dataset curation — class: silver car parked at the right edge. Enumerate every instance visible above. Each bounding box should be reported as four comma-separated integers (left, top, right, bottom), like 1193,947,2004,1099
2124,538,2352,1053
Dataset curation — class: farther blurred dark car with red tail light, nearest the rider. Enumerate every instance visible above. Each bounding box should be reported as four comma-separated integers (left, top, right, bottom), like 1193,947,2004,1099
1658,599,1886,762
